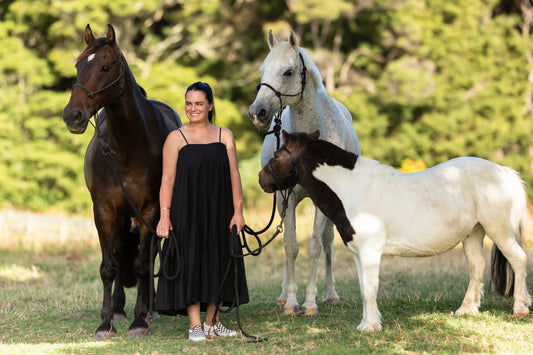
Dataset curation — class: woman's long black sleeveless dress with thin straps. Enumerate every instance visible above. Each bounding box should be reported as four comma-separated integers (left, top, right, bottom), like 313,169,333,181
155,130,249,315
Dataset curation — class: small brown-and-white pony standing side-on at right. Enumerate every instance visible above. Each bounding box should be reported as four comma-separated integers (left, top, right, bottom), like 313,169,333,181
259,131,531,331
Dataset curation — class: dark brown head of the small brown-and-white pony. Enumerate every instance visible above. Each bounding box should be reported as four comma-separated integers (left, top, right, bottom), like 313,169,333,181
259,130,319,192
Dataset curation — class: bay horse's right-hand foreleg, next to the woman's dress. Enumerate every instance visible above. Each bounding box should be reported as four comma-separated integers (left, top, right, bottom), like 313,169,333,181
128,224,152,337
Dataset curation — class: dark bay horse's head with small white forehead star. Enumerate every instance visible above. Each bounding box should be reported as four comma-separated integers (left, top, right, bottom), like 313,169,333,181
63,25,126,133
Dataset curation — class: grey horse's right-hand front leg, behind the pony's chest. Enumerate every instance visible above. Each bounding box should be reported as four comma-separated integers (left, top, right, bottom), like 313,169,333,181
302,206,327,316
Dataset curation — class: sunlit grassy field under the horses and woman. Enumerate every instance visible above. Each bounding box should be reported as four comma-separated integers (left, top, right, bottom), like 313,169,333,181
0,210,533,354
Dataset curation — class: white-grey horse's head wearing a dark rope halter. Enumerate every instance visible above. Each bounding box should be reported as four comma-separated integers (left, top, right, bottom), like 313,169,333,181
248,30,307,130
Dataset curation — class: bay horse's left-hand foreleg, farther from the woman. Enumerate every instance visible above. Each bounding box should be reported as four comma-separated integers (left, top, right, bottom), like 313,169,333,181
94,208,120,340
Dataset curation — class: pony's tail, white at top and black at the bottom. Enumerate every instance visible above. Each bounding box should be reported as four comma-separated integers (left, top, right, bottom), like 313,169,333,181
490,169,529,296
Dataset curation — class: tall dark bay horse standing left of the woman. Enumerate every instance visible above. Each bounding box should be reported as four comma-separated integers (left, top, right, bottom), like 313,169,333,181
63,25,181,339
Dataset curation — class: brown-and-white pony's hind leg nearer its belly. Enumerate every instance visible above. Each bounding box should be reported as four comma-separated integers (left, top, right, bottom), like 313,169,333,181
455,224,485,316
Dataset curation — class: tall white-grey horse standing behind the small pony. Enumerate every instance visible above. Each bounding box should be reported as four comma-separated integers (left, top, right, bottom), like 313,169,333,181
248,30,361,315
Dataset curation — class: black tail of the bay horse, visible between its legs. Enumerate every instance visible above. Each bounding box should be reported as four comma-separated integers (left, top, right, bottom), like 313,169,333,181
120,218,140,287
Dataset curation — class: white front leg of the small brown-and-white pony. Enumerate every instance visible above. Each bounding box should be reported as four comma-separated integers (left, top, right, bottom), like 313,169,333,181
354,248,381,332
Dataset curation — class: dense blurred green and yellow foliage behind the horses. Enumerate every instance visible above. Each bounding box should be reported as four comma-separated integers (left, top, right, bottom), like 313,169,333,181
0,0,533,213
